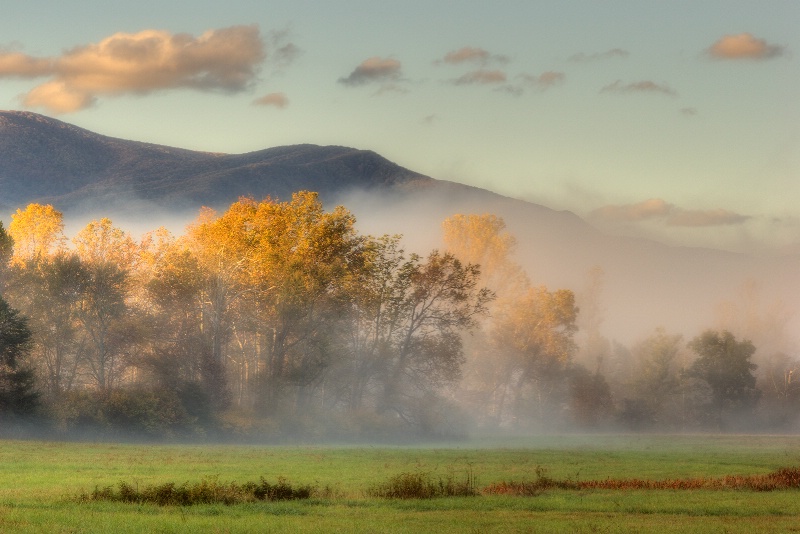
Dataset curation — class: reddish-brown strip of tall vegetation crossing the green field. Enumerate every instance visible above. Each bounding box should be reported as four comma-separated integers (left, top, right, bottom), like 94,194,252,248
483,467,800,495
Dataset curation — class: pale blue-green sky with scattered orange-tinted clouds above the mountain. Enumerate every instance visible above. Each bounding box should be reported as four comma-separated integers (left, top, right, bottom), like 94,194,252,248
0,0,800,254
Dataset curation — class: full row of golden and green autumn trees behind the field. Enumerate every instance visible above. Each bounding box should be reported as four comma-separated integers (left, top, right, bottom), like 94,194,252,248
0,192,800,439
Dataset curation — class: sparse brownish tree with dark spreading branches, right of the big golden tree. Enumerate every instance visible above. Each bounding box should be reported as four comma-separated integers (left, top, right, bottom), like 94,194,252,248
362,248,493,419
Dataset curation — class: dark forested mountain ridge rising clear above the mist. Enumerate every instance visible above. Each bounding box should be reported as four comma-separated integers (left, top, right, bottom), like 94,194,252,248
0,111,433,210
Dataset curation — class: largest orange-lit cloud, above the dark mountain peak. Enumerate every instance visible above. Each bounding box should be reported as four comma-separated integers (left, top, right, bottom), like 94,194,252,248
0,26,266,113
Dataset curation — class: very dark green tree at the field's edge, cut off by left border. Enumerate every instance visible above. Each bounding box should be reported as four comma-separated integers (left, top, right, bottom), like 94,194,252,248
0,296,39,421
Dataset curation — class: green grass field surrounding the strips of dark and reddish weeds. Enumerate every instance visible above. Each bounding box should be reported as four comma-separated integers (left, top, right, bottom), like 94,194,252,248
0,435,800,534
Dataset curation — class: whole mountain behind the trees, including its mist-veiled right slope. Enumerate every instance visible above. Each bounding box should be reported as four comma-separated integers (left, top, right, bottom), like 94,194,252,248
0,111,800,341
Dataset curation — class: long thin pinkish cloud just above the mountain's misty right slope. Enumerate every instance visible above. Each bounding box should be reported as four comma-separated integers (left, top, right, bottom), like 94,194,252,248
589,198,750,227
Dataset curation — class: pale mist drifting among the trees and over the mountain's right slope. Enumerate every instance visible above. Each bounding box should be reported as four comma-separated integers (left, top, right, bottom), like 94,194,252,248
5,183,800,442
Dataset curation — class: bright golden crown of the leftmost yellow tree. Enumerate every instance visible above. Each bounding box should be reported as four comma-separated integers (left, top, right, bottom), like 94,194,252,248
8,204,66,264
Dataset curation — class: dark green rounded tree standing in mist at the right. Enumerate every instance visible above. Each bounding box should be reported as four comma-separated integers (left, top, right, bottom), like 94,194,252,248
688,330,760,426
